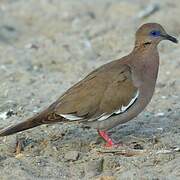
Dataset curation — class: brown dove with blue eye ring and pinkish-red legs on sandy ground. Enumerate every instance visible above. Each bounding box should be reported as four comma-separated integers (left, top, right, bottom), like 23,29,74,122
0,23,177,146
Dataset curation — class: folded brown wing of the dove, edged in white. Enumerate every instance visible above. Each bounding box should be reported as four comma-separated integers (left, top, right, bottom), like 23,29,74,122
54,61,138,121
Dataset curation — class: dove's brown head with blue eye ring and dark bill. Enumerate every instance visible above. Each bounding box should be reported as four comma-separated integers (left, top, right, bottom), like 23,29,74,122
136,23,178,45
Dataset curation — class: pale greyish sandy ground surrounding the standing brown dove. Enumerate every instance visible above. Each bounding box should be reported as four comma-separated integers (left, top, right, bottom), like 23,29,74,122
0,0,180,180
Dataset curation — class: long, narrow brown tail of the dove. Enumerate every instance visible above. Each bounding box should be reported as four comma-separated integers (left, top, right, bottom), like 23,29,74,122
0,108,57,137
